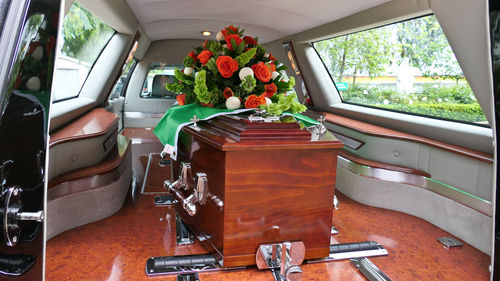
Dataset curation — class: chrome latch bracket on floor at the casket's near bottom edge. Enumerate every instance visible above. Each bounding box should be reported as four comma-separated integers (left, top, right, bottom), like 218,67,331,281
256,241,305,281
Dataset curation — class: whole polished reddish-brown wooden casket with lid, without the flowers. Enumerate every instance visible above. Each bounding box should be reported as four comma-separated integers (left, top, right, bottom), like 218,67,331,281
172,116,342,267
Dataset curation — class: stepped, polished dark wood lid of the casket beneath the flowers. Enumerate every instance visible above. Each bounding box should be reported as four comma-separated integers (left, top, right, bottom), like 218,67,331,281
183,115,342,151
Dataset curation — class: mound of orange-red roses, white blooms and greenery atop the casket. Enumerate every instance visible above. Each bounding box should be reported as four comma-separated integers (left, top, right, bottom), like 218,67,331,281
166,25,306,116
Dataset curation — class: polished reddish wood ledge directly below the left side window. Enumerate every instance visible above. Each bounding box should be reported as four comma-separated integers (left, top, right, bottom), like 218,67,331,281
50,108,119,146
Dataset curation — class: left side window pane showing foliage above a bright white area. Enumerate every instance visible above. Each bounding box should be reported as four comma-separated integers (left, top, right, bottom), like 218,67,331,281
53,2,115,101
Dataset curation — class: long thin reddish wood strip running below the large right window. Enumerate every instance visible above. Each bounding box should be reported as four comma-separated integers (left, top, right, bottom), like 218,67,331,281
321,112,493,164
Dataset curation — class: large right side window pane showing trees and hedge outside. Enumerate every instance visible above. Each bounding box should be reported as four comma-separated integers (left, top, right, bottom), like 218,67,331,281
314,15,488,125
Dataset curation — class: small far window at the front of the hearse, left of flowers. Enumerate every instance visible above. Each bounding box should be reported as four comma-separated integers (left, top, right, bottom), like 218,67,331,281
141,63,183,99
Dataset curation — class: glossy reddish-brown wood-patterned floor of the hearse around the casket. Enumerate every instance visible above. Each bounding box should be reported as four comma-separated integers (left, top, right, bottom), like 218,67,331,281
46,189,490,281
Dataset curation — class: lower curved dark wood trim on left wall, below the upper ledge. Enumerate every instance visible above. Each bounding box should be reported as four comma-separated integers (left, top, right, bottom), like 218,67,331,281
48,136,131,189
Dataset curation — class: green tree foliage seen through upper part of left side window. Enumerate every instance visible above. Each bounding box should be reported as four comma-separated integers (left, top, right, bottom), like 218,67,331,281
61,2,115,63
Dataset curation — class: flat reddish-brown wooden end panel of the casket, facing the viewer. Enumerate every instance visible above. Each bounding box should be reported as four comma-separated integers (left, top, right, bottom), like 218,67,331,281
223,148,337,266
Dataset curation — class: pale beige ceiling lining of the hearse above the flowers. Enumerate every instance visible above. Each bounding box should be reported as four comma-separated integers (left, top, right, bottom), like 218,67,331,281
126,0,389,43
